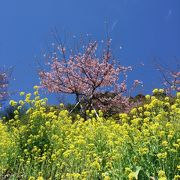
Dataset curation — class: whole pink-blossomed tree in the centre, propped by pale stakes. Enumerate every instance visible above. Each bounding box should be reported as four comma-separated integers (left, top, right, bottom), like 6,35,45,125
39,36,139,117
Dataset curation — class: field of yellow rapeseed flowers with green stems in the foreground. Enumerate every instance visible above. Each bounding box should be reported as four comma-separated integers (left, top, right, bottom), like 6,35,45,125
0,86,180,180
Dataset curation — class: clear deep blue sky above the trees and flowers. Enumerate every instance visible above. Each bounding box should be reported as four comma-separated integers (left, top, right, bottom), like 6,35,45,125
0,0,180,102
